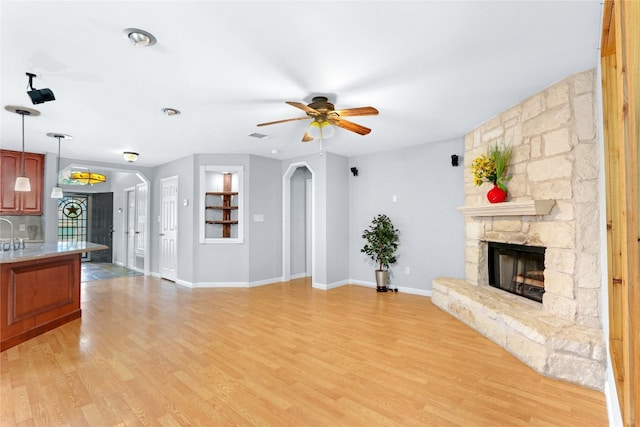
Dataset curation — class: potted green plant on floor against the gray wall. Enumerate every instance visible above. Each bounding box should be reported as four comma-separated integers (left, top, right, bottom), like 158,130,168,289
360,214,399,292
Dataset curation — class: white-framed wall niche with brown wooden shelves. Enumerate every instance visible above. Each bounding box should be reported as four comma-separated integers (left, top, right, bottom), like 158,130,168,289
200,166,244,243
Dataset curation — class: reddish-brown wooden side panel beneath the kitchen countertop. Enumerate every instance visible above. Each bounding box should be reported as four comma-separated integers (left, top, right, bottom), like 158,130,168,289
0,254,81,350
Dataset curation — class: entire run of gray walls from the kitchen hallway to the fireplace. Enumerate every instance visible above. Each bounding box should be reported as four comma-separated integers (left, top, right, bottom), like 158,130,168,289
44,139,465,293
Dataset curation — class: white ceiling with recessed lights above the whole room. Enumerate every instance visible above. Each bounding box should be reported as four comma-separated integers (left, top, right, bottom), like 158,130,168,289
0,0,602,166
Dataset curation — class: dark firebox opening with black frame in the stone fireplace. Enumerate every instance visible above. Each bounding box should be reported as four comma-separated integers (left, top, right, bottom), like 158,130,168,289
487,242,545,303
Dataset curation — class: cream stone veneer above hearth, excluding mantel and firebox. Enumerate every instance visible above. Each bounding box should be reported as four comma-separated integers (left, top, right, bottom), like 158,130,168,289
464,70,602,329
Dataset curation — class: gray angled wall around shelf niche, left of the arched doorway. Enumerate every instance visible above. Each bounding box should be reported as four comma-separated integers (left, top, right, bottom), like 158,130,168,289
151,154,282,286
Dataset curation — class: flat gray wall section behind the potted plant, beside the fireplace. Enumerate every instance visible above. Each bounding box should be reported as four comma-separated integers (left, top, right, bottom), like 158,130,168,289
349,139,468,294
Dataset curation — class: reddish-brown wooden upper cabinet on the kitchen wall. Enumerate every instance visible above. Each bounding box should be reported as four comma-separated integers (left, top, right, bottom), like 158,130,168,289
0,150,44,215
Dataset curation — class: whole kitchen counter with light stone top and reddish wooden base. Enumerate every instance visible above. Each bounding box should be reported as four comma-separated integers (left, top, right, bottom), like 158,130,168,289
0,242,108,351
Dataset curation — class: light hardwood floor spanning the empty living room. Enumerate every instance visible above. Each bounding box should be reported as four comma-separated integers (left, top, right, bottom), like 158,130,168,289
0,276,607,427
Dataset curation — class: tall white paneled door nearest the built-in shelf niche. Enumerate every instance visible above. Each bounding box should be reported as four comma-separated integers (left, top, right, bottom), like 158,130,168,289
160,176,178,282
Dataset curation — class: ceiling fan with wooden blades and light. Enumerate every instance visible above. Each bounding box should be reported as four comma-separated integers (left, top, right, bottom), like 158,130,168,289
258,96,378,142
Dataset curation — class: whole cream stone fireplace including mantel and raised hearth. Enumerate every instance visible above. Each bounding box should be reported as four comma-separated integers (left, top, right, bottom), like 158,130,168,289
432,70,606,390
